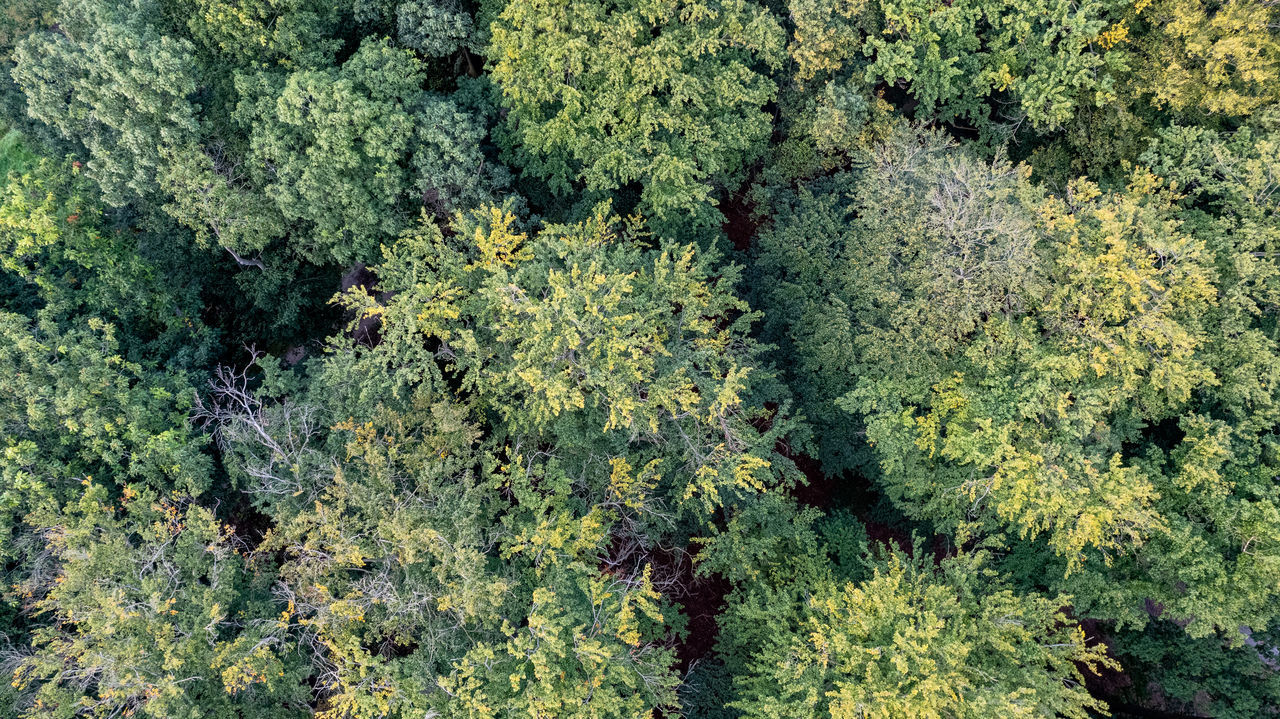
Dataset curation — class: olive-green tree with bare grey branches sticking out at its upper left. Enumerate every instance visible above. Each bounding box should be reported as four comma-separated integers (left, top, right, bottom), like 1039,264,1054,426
197,340,517,718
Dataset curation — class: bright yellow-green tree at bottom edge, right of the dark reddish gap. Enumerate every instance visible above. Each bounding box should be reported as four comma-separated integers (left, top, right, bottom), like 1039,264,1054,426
687,502,1108,716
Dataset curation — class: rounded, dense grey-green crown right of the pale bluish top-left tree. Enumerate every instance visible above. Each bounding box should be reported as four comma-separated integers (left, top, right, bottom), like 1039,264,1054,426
237,37,421,262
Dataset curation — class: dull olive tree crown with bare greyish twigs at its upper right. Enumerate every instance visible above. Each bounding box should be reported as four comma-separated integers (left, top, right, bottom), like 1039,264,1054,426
750,130,1042,473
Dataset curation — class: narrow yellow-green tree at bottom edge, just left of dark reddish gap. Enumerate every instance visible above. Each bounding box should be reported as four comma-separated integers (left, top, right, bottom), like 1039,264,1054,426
439,442,678,719
